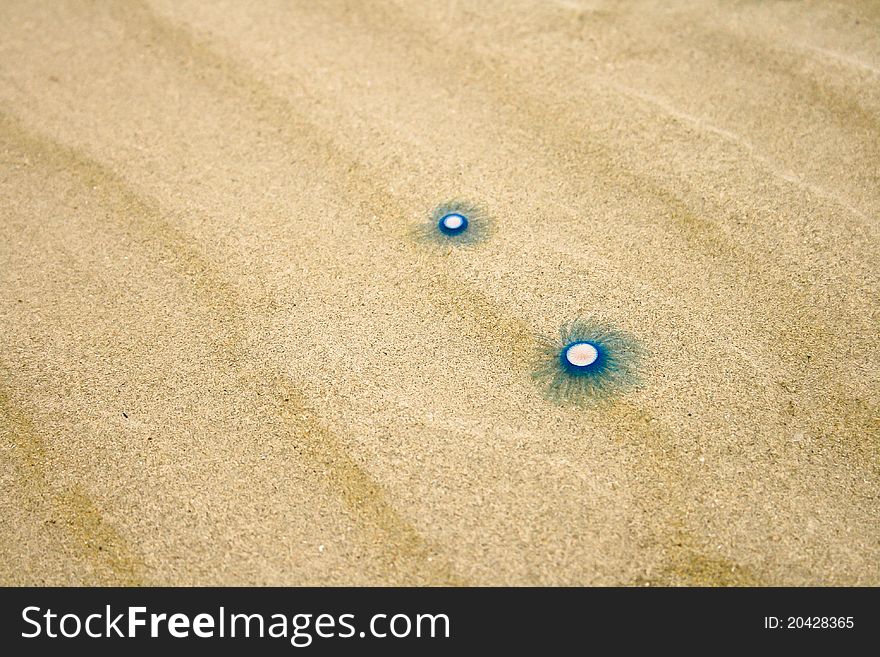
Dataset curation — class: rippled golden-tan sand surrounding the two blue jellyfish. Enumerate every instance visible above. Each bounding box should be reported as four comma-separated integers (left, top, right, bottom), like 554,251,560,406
0,0,880,585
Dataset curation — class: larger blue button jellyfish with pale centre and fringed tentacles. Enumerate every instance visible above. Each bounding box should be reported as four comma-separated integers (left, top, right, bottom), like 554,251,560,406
532,318,642,406
